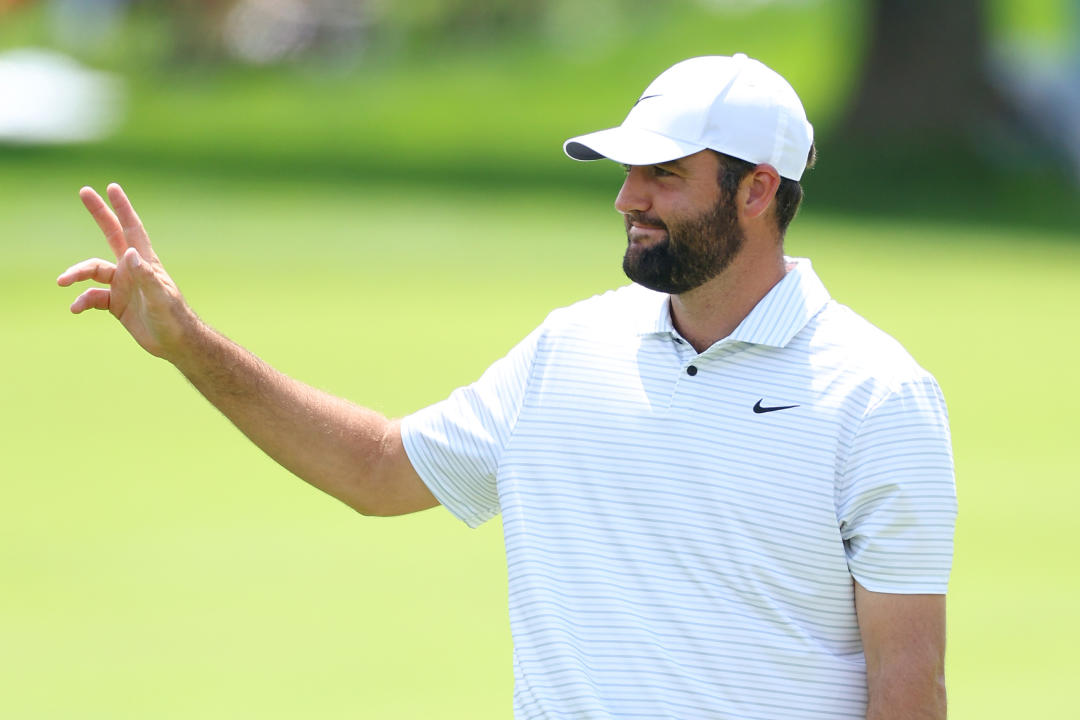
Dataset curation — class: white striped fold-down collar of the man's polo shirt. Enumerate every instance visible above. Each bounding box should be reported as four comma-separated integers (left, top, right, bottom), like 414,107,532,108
638,258,829,348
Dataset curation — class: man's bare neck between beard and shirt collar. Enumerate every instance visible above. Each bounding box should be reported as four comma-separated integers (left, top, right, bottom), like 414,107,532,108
671,239,787,353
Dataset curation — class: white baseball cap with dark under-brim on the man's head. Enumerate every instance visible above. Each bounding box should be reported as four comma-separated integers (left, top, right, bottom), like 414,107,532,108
563,53,813,180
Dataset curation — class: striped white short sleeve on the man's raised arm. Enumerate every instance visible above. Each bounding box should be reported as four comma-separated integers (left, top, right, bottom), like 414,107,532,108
402,328,541,528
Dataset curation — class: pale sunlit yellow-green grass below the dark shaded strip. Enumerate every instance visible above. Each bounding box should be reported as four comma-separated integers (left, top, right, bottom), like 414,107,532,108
0,156,1080,720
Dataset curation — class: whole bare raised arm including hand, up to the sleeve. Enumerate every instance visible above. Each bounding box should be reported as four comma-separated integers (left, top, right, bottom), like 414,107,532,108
56,185,438,515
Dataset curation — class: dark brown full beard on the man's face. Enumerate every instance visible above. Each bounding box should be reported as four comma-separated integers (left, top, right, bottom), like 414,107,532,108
622,192,744,295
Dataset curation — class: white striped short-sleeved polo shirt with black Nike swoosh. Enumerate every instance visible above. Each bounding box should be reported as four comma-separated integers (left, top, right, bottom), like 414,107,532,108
402,259,956,720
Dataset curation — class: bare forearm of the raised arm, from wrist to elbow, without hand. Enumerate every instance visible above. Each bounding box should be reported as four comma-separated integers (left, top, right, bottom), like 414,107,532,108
168,321,411,515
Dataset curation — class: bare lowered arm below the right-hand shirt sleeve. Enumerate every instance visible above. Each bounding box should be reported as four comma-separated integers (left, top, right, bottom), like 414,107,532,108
855,582,945,719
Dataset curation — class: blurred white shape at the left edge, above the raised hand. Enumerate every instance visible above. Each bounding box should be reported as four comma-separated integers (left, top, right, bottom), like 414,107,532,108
0,47,124,145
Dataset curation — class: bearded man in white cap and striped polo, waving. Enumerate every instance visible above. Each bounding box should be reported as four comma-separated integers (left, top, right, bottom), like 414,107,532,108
58,55,955,720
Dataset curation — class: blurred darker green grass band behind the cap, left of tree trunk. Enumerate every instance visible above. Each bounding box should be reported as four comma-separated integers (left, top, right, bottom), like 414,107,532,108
0,0,863,189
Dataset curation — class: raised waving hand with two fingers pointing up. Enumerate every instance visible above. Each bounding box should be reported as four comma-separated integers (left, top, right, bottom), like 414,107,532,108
56,184,198,359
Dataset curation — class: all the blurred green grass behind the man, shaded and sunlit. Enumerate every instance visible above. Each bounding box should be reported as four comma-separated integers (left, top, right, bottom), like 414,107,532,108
0,2,1080,720
